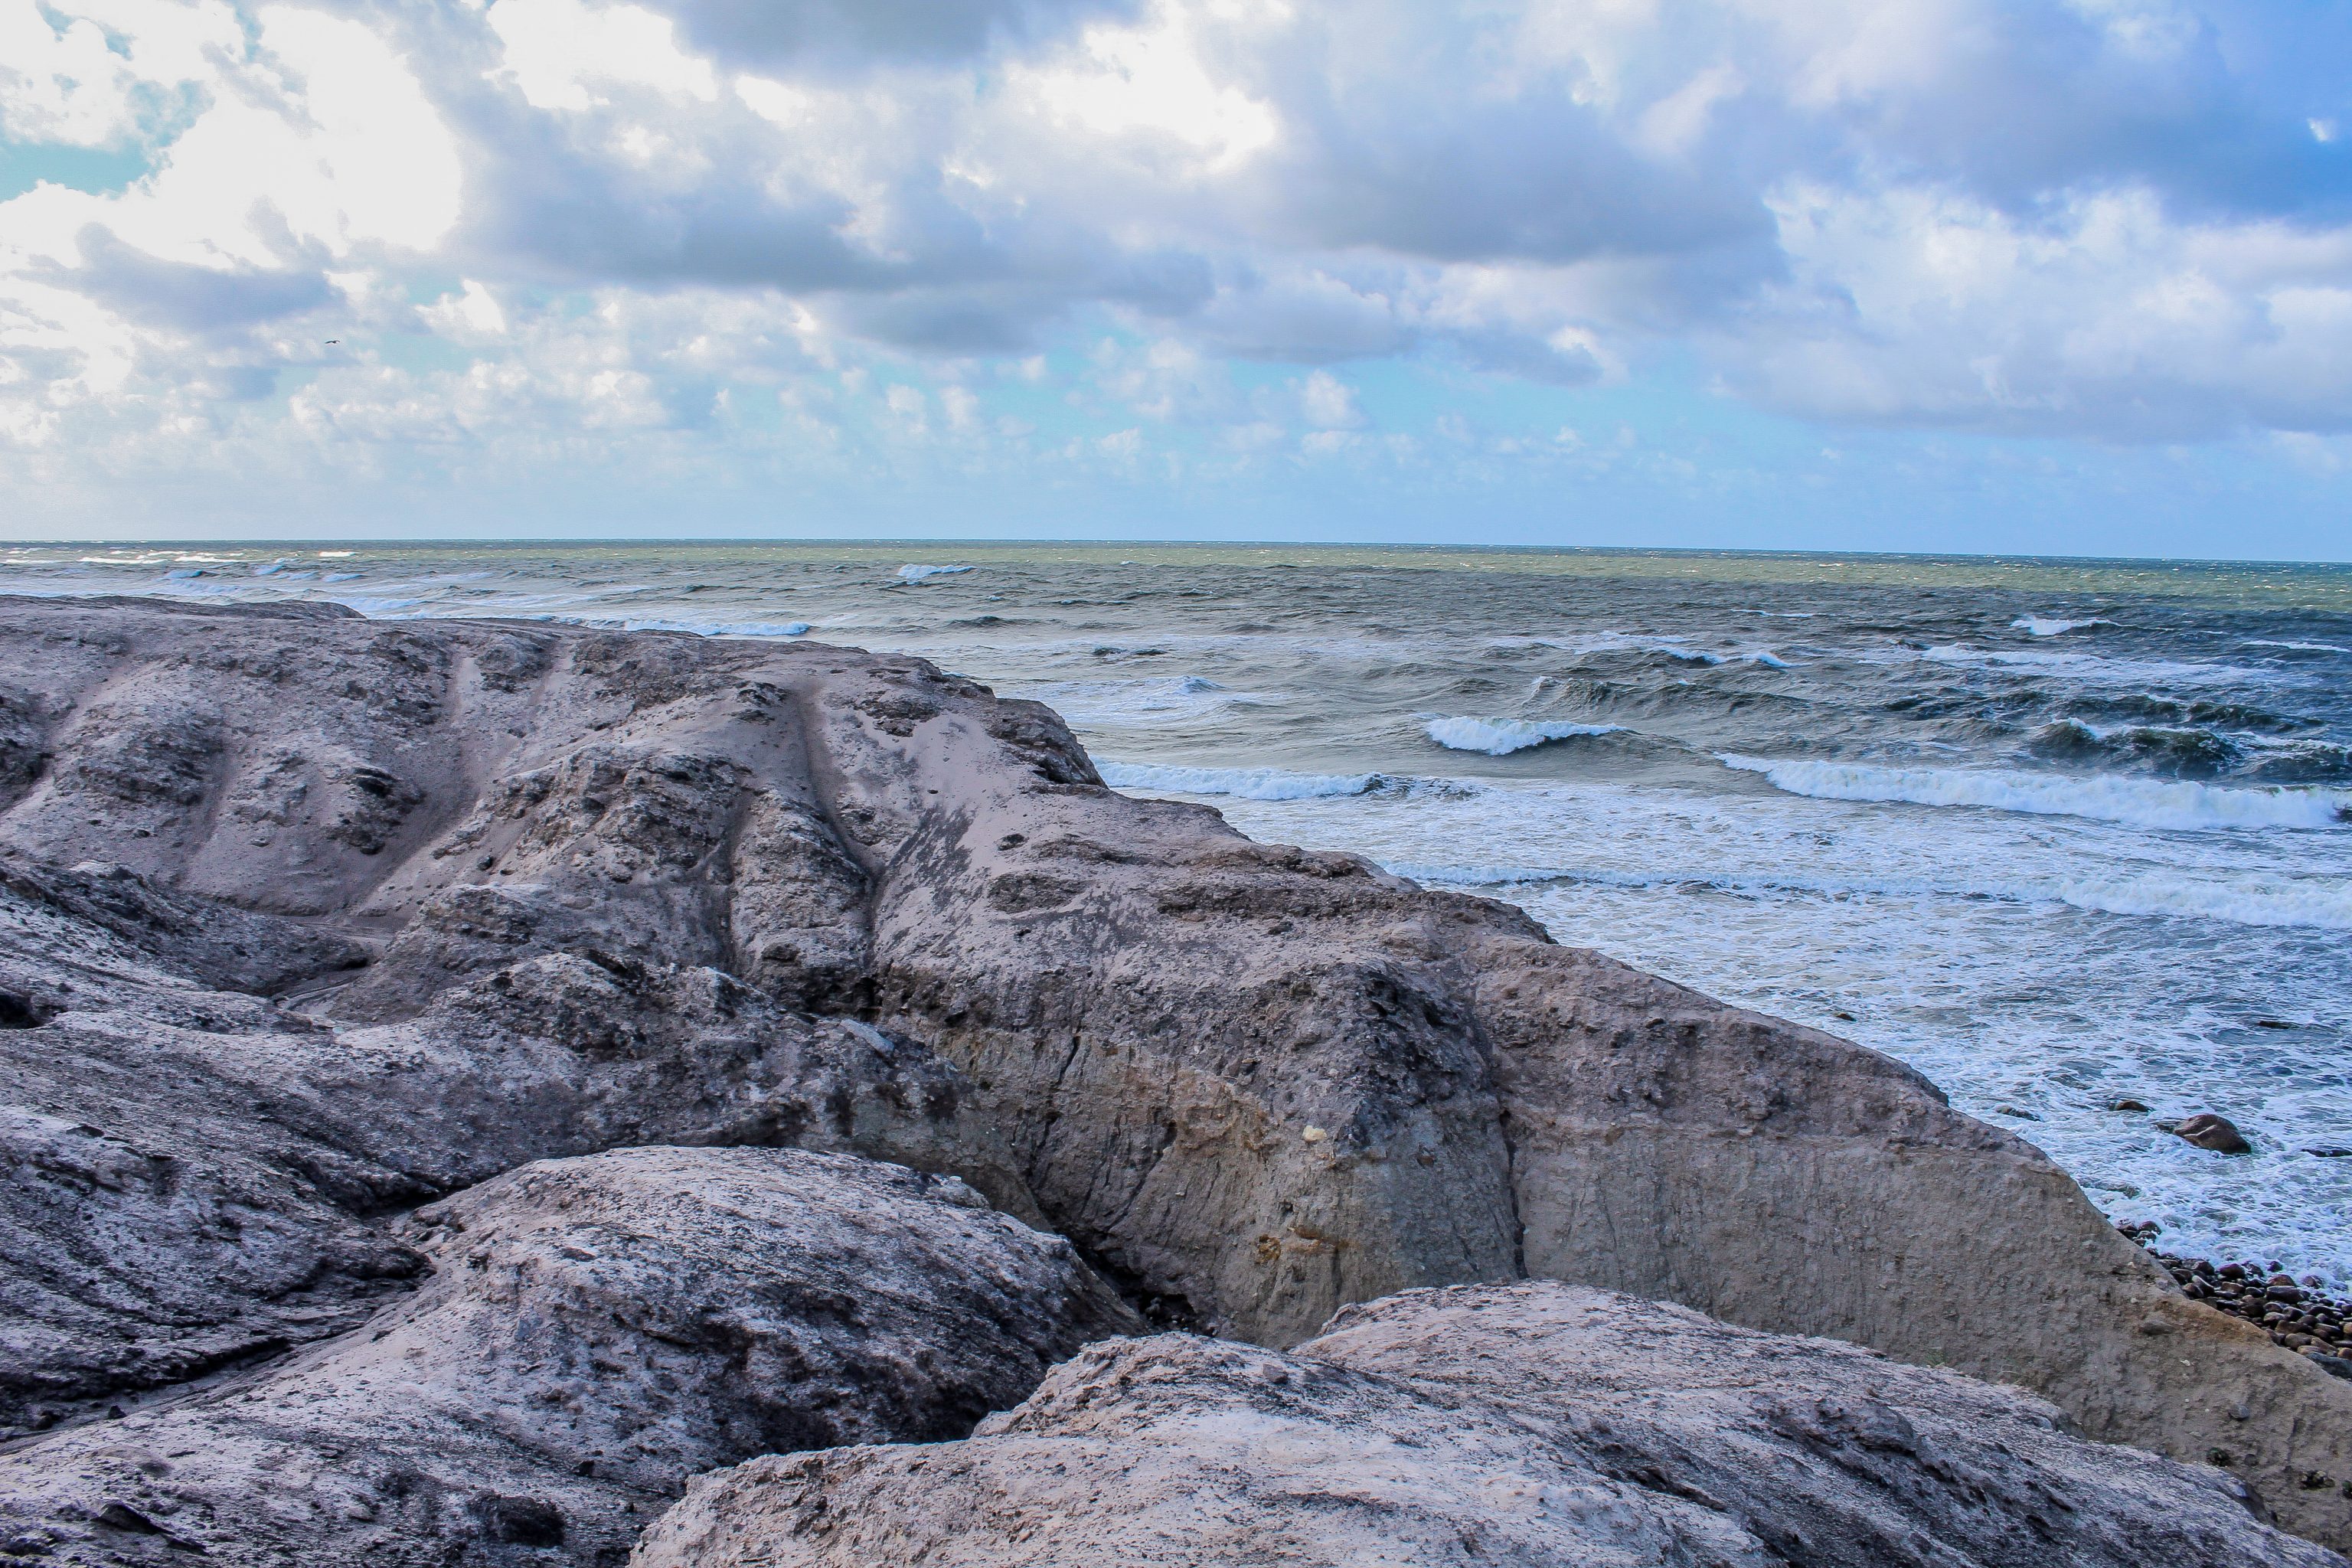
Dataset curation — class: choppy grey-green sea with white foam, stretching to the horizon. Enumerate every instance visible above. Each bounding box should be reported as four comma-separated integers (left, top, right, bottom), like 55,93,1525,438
0,543,2352,1289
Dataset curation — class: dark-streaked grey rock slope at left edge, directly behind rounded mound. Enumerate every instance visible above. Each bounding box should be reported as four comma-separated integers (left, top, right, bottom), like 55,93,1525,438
0,865,1037,1436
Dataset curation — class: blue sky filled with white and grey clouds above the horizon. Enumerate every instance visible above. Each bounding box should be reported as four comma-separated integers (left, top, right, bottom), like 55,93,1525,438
0,0,2352,560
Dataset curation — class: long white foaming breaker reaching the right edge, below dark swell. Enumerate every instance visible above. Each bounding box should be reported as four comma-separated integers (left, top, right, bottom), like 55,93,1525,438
1717,755,2352,830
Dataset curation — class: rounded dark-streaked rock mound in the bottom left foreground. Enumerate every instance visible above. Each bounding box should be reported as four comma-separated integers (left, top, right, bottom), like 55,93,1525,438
0,1147,1136,1568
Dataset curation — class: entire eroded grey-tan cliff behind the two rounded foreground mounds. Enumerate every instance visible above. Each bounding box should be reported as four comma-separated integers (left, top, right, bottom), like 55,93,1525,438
0,599,2352,1542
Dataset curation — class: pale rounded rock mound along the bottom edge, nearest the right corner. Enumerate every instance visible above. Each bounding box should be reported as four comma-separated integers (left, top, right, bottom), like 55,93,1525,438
630,1283,2343,1568
